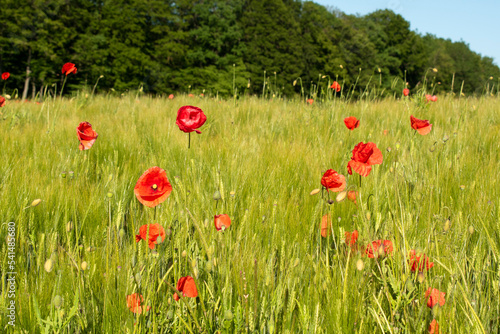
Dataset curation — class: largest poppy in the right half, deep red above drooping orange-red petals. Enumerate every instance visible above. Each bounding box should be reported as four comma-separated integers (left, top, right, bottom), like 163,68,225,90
347,142,384,176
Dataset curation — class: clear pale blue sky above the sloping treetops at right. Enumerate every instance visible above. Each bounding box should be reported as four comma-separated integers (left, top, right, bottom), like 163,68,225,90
313,0,500,65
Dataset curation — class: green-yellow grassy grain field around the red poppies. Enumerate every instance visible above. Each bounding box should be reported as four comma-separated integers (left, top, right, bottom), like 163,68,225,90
0,92,500,333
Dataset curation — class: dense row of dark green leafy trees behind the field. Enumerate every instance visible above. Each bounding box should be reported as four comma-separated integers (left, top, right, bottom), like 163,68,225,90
0,0,500,96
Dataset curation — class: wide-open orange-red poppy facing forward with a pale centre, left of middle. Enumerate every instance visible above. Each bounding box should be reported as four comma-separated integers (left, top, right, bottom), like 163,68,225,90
134,166,172,208
